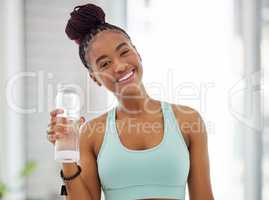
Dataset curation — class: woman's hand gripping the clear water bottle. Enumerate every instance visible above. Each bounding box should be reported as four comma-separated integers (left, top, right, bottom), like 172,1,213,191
47,109,85,144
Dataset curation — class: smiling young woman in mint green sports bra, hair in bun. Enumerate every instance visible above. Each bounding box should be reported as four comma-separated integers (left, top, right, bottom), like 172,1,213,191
47,4,213,200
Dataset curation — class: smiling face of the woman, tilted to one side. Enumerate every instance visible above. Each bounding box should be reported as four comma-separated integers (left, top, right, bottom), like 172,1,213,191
86,30,143,95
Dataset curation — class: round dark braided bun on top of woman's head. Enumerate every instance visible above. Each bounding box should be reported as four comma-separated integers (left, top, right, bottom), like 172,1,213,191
65,4,105,44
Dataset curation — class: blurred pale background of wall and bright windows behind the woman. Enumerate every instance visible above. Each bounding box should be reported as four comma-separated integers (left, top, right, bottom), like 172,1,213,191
0,0,269,200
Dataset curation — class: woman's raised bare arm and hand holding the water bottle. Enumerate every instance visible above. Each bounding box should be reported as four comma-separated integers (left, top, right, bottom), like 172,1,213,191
48,109,101,200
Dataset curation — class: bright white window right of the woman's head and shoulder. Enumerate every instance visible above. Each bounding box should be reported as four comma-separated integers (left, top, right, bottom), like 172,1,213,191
127,0,264,200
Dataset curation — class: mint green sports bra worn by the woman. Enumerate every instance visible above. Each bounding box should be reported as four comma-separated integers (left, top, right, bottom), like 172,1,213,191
97,101,190,200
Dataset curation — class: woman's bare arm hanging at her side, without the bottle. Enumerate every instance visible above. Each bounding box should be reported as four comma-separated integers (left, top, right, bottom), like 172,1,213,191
184,109,214,200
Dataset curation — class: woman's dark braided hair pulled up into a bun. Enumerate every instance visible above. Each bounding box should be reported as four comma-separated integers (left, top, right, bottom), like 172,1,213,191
65,4,131,72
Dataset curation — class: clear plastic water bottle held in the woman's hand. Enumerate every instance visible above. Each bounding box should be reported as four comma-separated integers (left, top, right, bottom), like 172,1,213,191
55,84,80,163
